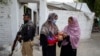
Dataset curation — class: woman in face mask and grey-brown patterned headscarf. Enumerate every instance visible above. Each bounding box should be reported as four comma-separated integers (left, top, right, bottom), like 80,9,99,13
40,13,58,56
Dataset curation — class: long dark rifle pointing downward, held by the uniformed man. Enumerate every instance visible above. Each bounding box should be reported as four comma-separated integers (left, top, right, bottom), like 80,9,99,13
9,25,23,56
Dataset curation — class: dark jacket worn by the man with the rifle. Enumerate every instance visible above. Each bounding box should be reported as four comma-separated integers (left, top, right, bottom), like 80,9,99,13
20,21,35,42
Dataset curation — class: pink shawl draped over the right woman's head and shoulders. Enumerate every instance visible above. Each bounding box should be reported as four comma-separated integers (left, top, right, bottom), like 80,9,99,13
63,17,80,49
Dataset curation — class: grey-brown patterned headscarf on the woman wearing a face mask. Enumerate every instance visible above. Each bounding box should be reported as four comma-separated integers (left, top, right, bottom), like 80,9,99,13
41,13,58,36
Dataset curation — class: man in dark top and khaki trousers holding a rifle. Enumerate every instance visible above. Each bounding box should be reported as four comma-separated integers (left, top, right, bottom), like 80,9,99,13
12,14,35,56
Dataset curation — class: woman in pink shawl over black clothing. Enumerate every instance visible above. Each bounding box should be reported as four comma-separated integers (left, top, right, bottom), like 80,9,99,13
58,16,80,56
